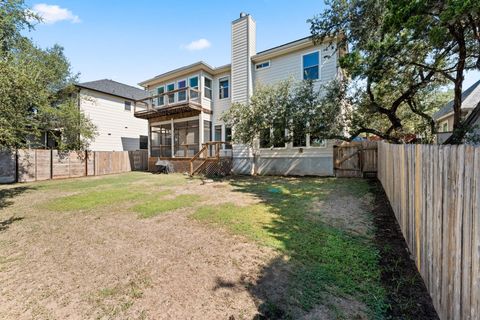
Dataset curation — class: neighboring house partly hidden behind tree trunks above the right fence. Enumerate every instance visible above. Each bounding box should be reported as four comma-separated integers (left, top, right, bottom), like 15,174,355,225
433,80,480,144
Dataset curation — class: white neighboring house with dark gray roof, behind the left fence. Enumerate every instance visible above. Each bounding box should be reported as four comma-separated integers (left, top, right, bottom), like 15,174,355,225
76,79,148,151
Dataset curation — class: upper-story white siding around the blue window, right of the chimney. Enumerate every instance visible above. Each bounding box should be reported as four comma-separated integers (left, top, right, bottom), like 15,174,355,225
253,45,338,88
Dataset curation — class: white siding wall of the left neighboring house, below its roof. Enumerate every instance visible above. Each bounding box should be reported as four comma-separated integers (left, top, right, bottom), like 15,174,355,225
80,89,148,151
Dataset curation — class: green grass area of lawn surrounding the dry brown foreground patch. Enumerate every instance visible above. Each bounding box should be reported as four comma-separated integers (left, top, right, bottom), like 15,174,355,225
0,172,387,319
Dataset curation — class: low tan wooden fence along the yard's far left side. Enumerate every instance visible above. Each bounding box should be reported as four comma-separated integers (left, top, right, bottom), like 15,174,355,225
0,149,148,183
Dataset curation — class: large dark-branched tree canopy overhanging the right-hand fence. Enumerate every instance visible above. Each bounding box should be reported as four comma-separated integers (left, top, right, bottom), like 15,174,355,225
309,0,480,141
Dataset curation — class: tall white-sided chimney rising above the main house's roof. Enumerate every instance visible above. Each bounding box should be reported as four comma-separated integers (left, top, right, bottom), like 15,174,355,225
231,16,256,102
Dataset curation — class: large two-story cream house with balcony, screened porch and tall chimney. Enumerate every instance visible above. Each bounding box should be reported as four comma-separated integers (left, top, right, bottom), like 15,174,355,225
131,13,340,175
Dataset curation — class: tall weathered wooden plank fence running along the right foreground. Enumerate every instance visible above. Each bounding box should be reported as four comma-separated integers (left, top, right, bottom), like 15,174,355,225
378,143,480,320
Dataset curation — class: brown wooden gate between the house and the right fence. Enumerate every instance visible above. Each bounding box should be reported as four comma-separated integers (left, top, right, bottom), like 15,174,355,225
333,141,377,178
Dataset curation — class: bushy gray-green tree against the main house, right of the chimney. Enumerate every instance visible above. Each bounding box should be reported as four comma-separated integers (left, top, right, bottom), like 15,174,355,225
222,80,343,147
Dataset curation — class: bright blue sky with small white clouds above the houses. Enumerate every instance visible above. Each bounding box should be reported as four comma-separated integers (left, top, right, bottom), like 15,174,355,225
27,0,480,88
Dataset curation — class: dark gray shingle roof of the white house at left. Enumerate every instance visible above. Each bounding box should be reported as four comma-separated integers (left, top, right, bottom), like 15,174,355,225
77,79,148,100
